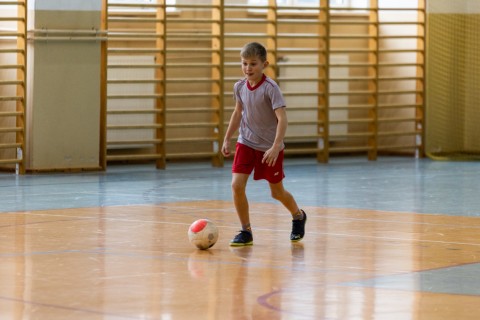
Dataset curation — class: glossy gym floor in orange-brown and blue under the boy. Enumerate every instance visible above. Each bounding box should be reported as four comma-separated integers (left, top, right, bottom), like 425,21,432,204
0,158,480,320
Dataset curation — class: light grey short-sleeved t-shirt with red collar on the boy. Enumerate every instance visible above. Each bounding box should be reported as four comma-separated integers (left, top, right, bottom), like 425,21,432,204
233,75,286,151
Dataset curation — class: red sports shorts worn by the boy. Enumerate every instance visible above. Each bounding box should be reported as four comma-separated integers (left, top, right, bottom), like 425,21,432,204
232,143,285,183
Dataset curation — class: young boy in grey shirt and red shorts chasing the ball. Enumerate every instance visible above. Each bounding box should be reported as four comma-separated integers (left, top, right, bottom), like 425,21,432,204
222,42,307,246
